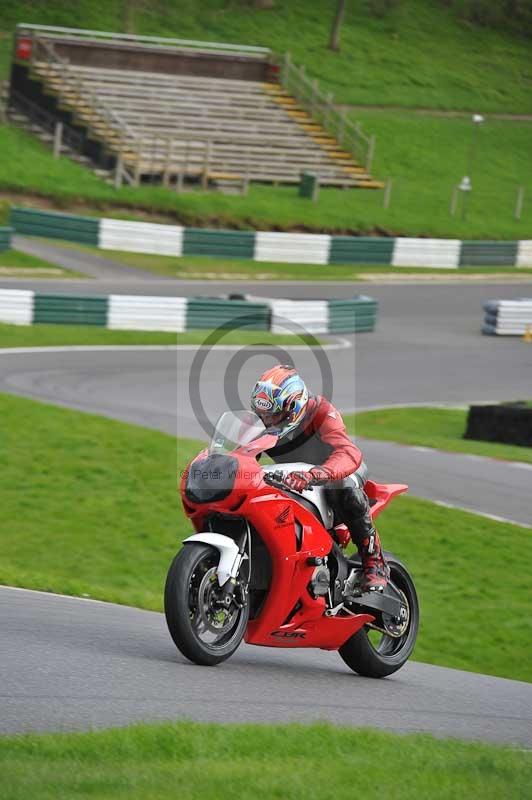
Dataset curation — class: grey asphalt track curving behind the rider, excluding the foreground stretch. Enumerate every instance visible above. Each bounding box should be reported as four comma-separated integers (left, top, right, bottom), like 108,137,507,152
0,281,532,525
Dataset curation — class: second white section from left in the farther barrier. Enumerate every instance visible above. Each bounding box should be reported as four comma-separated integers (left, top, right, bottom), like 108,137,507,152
255,231,331,264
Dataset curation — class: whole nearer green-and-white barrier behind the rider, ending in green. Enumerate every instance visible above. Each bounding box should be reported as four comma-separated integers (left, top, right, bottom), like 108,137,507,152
0,289,377,334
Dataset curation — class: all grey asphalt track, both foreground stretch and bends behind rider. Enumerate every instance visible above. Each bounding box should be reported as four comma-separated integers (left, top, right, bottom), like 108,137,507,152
0,281,532,747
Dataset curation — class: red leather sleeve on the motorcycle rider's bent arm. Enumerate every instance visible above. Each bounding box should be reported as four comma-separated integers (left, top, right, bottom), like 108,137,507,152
308,397,362,481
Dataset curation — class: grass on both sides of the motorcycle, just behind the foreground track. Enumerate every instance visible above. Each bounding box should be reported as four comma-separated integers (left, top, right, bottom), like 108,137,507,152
0,395,532,681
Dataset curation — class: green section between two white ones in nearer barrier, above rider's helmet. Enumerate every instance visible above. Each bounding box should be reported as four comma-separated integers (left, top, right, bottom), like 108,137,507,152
186,297,270,331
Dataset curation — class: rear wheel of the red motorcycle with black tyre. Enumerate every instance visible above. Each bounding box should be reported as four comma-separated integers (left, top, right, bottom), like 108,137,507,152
338,553,419,678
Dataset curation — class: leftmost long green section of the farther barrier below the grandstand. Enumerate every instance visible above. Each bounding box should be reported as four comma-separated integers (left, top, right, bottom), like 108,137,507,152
9,208,100,245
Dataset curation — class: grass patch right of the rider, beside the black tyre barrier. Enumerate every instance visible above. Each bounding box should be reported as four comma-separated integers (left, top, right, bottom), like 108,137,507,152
344,406,532,464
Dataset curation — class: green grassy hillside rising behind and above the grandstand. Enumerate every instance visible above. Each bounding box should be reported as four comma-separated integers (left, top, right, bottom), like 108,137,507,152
0,0,532,113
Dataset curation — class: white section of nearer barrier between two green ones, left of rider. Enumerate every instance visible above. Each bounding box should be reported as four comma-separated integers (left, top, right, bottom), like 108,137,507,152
107,294,187,333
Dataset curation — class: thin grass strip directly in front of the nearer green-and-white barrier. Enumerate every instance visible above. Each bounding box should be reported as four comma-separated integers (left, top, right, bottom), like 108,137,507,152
0,323,323,349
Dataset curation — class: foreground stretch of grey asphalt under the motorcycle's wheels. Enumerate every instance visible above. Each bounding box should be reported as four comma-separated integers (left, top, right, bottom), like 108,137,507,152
4,588,532,747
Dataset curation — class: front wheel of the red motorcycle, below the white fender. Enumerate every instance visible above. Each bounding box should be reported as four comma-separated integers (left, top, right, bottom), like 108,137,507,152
164,544,249,666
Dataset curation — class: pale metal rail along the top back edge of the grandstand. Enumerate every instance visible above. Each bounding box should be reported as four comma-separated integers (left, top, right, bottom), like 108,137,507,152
17,22,272,59
